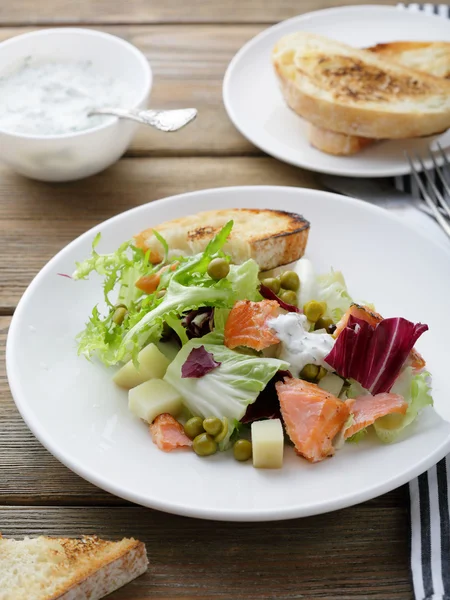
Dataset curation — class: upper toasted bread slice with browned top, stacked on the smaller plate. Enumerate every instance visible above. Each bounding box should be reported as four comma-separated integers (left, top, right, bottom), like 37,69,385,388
272,32,450,139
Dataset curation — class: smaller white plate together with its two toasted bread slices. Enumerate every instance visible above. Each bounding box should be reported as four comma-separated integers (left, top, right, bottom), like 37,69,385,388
223,6,450,177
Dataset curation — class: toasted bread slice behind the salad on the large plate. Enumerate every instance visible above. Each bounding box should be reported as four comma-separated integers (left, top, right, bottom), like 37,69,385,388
135,208,309,271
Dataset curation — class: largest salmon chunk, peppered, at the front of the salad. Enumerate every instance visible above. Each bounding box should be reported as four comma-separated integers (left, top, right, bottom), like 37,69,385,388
275,378,349,462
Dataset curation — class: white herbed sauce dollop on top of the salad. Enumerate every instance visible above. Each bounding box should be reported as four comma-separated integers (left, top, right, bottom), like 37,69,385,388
268,313,335,377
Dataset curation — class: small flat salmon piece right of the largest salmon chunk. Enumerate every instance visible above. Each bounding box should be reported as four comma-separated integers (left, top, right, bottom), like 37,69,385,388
344,394,408,439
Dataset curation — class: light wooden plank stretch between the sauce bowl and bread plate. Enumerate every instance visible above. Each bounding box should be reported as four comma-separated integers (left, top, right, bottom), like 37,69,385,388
0,25,263,156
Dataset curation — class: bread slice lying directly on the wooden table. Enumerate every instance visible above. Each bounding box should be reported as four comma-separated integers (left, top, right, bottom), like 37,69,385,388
0,536,148,600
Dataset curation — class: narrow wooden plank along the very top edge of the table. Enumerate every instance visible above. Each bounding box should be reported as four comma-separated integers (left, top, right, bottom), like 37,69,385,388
0,0,395,25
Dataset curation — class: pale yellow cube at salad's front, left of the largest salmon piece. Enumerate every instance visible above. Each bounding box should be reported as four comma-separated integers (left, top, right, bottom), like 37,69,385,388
252,419,284,469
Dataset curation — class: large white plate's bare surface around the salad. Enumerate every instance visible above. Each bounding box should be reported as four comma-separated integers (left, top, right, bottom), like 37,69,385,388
6,187,450,521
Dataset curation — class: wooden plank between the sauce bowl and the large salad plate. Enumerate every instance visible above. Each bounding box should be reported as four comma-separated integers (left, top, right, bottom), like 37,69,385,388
0,157,317,314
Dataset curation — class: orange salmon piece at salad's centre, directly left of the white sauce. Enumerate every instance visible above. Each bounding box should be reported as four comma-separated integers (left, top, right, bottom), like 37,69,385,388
224,300,280,350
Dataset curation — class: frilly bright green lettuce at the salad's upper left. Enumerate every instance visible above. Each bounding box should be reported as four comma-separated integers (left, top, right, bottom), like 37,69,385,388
73,221,261,366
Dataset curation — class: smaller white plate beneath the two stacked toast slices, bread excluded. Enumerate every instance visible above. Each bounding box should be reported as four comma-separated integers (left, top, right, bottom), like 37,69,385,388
223,6,450,177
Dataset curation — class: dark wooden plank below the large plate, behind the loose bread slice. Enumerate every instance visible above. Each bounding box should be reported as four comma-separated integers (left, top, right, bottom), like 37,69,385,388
0,504,413,600
